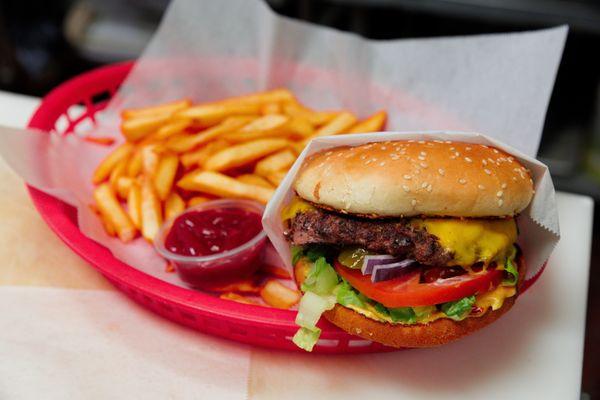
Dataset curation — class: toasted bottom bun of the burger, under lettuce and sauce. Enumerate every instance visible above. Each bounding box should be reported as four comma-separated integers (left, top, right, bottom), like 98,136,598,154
294,255,525,348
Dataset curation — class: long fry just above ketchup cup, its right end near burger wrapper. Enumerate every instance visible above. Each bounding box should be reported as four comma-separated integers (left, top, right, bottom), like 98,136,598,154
177,170,274,204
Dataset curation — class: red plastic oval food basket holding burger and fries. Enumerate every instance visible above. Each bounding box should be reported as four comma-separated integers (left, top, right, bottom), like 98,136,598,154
28,62,393,353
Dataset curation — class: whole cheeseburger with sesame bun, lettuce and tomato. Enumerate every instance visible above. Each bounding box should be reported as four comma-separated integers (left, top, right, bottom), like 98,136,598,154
282,141,533,351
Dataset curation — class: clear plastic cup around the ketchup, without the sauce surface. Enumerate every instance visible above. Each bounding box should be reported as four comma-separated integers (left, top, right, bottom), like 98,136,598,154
154,199,267,289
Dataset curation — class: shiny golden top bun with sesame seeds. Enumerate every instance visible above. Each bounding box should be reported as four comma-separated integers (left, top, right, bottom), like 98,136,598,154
294,140,533,217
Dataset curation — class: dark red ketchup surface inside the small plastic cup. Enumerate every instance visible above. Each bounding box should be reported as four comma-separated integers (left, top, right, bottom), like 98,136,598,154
165,207,262,256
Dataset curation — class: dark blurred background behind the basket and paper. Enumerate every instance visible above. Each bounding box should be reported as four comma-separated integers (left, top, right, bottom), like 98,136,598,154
0,0,600,398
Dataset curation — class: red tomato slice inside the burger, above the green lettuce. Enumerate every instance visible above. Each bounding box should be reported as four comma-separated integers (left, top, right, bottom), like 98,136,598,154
334,260,502,308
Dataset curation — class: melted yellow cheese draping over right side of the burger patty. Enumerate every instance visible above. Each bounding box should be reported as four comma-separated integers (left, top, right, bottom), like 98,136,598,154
411,218,517,266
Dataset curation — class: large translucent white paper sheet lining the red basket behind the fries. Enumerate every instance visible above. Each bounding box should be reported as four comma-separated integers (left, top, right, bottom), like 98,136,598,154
0,0,567,286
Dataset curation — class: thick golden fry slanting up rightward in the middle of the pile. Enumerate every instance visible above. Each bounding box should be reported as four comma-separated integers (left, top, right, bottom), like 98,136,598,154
202,138,290,171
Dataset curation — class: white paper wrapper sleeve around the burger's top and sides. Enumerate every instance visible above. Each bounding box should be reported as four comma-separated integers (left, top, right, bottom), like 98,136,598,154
263,131,560,279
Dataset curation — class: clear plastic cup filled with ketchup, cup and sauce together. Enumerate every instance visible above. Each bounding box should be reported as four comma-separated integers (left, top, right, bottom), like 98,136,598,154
154,199,267,289
